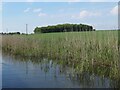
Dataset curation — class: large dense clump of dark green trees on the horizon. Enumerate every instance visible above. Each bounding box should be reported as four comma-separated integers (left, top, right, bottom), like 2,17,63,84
34,24,95,33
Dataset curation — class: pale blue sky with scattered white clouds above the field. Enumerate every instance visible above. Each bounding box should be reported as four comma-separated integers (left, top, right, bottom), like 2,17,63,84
0,0,118,33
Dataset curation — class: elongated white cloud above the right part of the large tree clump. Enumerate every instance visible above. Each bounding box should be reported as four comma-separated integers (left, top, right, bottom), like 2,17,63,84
79,10,101,18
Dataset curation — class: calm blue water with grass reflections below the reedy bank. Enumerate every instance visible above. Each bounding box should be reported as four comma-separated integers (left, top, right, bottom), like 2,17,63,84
2,55,118,88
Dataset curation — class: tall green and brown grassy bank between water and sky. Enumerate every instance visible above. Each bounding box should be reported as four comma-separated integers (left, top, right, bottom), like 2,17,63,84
2,31,120,78
